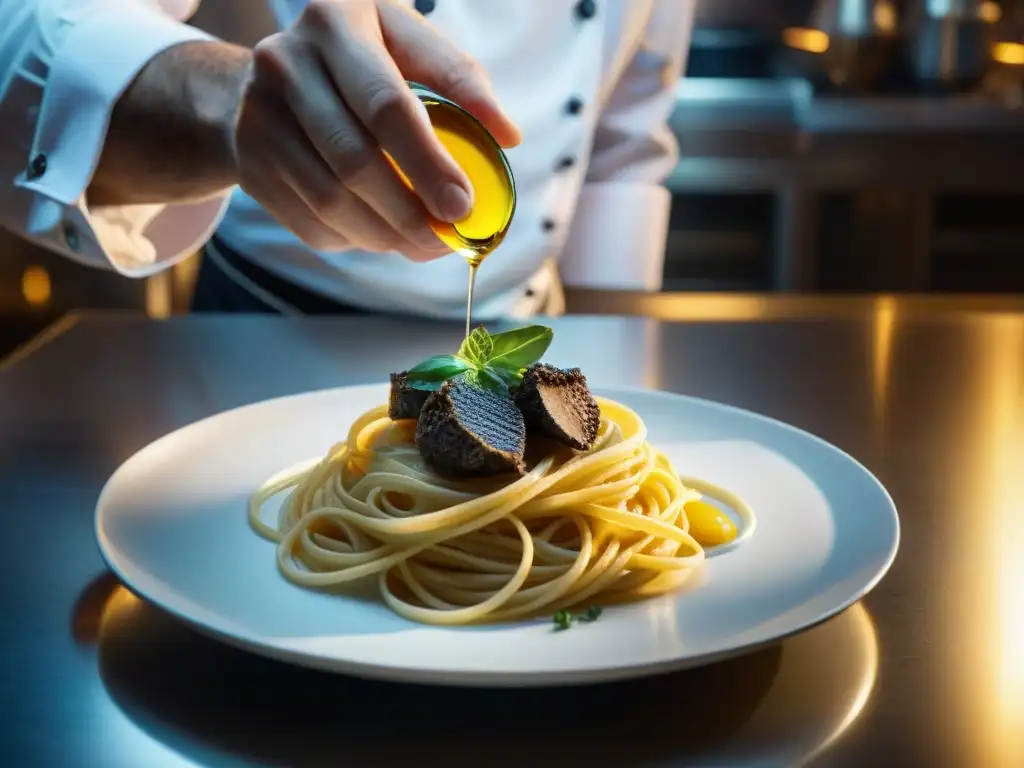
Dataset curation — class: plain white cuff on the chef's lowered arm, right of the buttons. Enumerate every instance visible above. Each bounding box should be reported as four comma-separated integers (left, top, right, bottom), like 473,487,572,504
559,182,672,291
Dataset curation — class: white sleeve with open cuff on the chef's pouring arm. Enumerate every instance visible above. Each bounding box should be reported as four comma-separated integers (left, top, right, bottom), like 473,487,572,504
0,0,228,278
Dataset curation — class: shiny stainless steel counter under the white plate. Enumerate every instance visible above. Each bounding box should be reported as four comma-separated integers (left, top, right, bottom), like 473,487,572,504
0,303,1024,768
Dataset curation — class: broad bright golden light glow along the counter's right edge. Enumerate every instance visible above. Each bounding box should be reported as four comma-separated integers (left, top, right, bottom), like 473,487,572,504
939,313,1024,766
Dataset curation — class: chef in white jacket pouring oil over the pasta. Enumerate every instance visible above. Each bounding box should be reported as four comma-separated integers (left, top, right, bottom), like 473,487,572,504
0,0,694,319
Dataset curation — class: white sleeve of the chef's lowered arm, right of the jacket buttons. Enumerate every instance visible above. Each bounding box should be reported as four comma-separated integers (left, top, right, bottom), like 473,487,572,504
559,0,695,291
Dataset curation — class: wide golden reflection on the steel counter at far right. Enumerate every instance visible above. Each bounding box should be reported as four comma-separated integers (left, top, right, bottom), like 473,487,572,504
962,316,1024,766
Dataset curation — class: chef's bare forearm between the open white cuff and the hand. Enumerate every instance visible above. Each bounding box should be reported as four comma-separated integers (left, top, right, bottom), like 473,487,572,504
87,42,252,205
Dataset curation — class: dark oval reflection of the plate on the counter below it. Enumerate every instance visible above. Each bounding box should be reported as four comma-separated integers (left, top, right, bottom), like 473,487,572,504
73,577,878,768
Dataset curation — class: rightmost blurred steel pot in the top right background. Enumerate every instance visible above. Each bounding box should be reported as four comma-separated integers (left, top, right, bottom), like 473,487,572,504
907,0,1001,92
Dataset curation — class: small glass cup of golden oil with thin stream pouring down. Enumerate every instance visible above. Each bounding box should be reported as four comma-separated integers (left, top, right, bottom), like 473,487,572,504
399,83,515,336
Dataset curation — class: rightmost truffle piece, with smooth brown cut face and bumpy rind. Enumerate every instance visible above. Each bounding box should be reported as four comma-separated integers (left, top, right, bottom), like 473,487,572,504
515,362,601,451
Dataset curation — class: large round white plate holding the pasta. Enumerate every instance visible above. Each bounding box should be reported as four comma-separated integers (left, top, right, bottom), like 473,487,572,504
96,385,899,685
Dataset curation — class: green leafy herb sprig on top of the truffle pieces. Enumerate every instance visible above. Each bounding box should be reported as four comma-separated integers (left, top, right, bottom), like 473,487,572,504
408,326,554,392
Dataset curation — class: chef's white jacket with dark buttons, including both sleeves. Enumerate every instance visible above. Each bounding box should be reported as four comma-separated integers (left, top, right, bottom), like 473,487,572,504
0,0,695,318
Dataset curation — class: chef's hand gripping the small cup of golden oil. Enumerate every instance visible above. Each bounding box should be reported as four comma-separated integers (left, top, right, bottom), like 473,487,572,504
236,0,520,260
